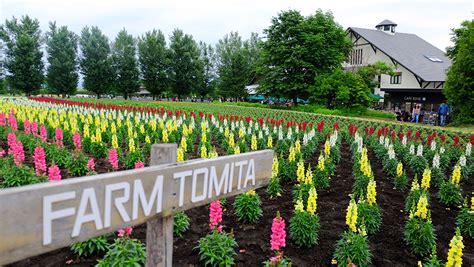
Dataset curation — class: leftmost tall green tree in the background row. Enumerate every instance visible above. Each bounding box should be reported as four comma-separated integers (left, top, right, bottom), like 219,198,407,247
0,16,44,95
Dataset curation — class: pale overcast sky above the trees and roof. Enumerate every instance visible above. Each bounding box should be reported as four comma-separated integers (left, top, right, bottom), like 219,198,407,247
0,0,474,50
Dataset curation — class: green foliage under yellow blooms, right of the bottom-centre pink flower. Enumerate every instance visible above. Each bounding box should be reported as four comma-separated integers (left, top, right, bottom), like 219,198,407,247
290,211,320,247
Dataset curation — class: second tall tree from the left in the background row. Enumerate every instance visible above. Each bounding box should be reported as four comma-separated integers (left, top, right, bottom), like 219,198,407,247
46,22,79,96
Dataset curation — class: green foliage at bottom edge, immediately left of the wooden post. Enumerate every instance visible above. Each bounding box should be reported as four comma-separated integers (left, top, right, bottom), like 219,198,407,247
96,237,146,267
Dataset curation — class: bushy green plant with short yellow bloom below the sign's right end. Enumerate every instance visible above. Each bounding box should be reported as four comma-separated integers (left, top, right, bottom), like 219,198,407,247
234,190,263,224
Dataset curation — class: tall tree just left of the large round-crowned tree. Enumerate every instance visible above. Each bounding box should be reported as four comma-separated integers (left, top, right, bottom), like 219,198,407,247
216,32,258,98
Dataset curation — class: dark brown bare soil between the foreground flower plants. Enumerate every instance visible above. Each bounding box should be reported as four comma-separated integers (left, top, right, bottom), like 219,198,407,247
7,140,474,267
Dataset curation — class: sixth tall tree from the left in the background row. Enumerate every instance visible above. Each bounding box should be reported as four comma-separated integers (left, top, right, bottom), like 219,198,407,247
170,29,203,98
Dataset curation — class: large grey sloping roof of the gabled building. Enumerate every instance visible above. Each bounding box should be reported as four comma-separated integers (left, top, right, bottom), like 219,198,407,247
348,27,451,82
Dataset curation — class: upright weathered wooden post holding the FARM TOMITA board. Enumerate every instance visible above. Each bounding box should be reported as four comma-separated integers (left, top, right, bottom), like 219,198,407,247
146,144,177,267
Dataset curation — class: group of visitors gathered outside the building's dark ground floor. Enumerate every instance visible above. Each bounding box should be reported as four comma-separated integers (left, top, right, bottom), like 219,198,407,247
395,102,450,126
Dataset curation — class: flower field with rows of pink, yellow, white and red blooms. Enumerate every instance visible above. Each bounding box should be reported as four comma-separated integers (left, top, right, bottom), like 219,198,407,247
0,98,474,266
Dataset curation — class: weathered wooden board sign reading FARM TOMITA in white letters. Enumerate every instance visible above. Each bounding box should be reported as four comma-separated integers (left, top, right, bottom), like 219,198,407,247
0,145,273,266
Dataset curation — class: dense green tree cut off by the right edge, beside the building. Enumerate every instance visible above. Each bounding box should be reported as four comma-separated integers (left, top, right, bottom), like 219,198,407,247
443,21,474,123
